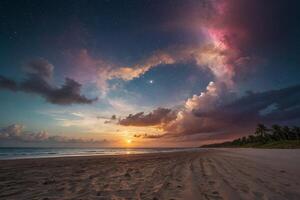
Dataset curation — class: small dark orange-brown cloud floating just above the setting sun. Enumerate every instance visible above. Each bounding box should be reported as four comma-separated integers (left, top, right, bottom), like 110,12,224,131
119,108,176,126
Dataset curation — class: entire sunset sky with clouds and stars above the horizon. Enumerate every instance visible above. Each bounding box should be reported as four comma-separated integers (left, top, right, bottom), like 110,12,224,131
0,0,300,147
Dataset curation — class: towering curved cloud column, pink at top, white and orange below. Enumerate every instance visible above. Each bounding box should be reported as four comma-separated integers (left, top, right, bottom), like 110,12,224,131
113,1,258,144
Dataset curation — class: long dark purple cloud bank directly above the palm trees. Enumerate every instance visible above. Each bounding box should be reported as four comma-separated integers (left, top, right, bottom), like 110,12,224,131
179,85,300,135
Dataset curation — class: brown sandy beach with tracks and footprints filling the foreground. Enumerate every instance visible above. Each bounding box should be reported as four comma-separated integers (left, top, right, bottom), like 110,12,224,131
0,149,300,200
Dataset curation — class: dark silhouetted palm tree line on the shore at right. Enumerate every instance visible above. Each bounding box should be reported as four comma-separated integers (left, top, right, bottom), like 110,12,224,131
202,124,300,147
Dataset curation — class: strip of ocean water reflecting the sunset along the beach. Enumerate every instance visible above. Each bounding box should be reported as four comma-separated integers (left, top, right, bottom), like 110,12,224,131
0,147,191,160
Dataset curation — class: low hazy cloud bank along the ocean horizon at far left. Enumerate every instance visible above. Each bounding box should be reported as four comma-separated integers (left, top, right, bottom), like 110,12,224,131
0,124,109,145
